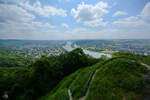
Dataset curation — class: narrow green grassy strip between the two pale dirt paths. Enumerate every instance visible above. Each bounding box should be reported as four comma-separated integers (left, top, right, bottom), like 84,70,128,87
71,62,102,100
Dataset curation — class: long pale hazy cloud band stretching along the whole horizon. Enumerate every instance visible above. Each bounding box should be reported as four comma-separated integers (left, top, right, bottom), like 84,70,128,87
0,23,150,40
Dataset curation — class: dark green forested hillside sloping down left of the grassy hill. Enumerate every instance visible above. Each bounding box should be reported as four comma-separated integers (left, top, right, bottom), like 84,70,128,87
0,48,99,100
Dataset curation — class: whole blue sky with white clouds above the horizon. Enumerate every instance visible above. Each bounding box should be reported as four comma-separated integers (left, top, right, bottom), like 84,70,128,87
0,0,150,40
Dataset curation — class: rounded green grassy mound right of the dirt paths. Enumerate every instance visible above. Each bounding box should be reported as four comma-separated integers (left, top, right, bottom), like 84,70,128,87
86,59,146,100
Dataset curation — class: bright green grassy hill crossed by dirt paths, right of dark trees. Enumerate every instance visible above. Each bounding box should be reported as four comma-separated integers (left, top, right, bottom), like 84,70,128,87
38,53,149,100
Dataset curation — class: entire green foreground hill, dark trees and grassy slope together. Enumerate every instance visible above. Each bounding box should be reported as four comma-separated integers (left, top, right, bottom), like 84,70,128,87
0,48,150,100
